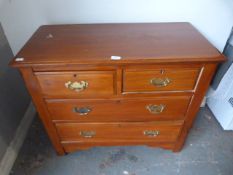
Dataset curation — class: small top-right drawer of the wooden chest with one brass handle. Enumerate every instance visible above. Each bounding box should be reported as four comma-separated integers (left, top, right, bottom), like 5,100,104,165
123,67,200,93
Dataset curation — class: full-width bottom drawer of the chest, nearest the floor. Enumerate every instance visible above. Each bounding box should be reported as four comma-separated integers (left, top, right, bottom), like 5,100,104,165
56,121,182,142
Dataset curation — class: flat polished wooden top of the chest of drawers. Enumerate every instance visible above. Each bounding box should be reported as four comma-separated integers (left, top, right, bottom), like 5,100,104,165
11,23,224,66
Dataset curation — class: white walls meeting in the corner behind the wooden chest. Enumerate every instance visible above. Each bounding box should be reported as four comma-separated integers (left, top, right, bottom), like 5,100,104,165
0,0,233,53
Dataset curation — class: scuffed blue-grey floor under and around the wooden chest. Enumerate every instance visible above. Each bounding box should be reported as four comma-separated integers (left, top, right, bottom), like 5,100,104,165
11,108,233,175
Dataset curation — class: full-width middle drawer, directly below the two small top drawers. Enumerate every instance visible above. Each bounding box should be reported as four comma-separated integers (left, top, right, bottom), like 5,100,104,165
46,96,191,122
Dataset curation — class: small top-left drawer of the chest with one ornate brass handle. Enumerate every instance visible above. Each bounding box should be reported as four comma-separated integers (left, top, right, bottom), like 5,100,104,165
35,71,115,98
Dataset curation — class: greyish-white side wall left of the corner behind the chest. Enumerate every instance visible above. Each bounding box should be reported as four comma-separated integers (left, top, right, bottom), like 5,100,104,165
0,0,45,54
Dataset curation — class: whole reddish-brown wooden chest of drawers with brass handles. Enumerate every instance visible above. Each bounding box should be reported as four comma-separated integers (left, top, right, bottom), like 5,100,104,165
11,23,224,155
